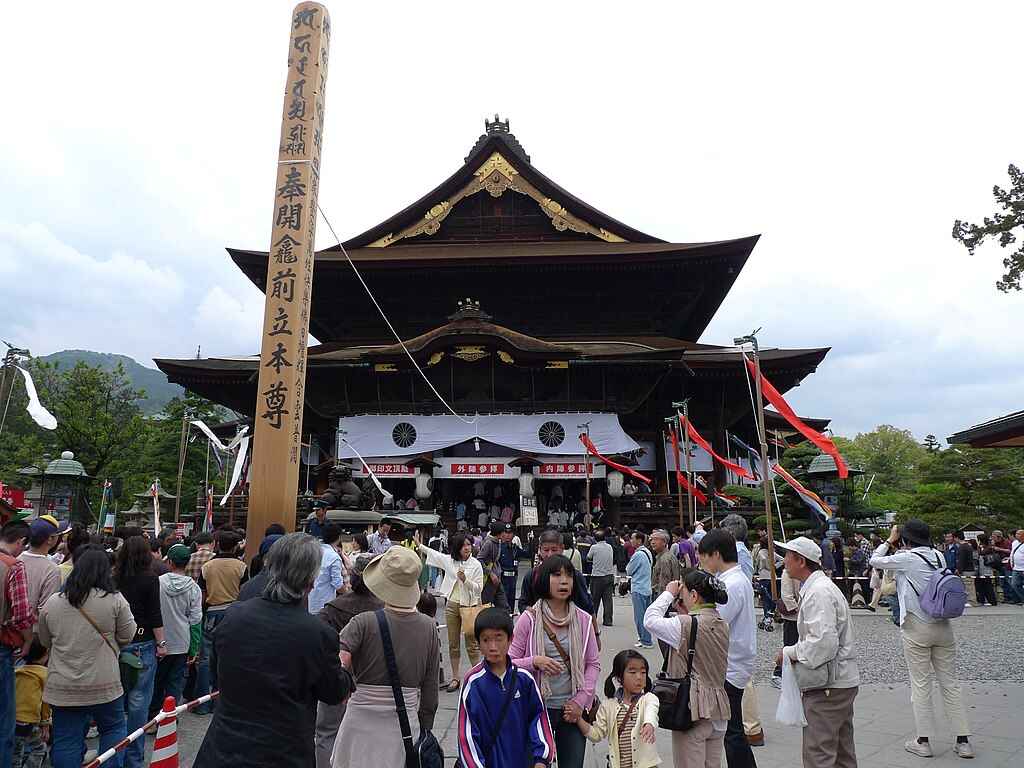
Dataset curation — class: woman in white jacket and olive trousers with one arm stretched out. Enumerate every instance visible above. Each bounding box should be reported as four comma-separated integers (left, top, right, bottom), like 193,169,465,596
419,531,483,692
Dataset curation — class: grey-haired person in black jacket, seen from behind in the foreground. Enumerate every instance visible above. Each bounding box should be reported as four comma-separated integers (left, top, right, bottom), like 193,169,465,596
194,534,355,768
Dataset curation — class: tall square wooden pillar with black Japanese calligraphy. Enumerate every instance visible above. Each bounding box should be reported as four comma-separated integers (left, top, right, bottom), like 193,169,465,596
247,2,331,551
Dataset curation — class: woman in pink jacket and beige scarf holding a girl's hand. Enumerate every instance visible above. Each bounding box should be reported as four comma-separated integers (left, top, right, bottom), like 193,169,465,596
509,555,601,768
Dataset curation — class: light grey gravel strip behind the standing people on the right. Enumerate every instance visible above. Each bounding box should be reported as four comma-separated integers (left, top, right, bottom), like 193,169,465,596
757,606,1024,685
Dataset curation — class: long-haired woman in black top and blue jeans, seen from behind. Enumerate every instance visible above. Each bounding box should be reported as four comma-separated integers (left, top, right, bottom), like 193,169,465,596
114,536,167,768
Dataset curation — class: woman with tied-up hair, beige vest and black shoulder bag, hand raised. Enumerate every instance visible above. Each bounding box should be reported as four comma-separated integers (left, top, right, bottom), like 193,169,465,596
644,569,730,768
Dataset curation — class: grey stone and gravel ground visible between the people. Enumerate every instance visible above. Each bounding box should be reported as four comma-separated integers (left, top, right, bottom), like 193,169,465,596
150,596,1024,768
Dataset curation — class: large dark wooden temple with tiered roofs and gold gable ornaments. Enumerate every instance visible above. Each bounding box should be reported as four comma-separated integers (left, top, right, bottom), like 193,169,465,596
156,116,828,524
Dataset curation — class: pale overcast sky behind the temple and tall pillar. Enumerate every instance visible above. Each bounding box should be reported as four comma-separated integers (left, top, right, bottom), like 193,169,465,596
0,0,1024,438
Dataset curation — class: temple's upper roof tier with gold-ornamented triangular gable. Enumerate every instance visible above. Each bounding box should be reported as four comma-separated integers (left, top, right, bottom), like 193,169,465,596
227,116,758,345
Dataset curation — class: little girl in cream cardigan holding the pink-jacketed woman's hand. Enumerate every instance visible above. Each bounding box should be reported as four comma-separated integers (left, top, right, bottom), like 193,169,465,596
577,649,662,768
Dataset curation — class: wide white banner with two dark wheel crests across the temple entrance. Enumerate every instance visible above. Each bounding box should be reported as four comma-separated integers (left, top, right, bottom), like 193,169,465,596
338,413,639,459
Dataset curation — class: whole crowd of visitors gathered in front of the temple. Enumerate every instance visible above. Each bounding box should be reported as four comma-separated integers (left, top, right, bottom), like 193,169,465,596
0,515,1024,768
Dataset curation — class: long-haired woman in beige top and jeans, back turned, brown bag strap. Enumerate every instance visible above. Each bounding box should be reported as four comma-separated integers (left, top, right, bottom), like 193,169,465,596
38,545,136,768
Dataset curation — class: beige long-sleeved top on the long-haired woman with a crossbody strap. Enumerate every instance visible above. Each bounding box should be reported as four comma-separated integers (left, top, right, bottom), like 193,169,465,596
38,590,135,707
